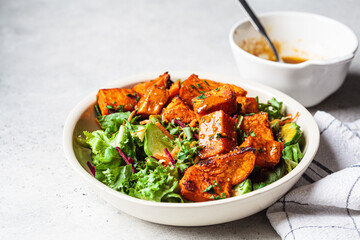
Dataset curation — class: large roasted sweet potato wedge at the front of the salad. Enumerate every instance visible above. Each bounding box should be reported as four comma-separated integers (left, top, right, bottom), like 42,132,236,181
180,149,255,202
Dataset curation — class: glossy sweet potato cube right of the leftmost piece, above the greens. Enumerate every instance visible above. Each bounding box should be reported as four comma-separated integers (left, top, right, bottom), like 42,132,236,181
137,86,169,117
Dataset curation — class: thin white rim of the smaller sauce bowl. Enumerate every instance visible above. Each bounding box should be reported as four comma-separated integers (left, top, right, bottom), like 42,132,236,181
229,11,359,69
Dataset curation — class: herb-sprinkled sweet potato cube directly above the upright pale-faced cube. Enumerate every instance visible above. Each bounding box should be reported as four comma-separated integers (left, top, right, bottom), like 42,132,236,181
192,85,237,116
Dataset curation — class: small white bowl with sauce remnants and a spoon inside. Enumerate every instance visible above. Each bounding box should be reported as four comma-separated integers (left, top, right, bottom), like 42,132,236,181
229,12,358,107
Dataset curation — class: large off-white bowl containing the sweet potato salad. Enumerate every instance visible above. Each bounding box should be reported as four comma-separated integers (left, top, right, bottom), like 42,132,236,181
63,72,320,226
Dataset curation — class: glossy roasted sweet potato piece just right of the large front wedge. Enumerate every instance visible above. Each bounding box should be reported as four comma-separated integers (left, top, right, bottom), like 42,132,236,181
240,136,284,167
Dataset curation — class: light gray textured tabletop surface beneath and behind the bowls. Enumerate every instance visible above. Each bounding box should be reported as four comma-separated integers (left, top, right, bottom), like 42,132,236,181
0,0,360,239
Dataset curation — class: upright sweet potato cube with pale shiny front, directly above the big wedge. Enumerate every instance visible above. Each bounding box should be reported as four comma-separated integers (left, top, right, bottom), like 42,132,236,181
199,110,237,159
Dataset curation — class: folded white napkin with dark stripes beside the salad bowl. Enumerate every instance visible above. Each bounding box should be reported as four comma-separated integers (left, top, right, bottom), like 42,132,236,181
267,112,360,240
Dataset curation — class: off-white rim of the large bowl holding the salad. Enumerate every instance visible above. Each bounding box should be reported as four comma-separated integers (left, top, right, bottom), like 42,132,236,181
63,71,320,208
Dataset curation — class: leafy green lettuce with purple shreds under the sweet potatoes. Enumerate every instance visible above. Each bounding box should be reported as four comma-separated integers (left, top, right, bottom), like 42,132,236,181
78,95,303,202
